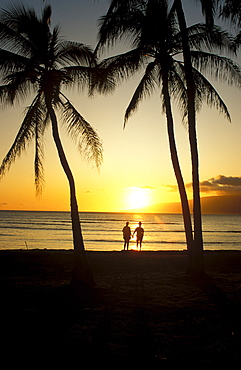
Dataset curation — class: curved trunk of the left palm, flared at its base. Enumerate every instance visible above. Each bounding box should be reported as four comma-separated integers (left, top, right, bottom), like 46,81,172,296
46,96,95,286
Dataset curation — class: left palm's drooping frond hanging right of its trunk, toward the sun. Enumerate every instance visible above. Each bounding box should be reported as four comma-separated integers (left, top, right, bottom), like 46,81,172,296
60,94,103,168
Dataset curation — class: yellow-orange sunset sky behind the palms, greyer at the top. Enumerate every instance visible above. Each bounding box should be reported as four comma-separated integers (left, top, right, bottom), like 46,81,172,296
0,0,241,212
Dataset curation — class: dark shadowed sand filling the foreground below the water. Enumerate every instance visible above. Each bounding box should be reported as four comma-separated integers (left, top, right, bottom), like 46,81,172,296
0,250,241,369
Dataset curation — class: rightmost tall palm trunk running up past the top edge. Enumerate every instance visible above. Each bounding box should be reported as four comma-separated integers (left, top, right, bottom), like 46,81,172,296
176,0,204,273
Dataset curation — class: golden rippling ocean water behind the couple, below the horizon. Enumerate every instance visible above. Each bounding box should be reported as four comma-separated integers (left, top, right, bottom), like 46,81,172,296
0,211,241,251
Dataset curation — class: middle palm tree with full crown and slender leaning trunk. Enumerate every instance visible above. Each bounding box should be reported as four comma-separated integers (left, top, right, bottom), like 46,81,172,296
98,0,239,271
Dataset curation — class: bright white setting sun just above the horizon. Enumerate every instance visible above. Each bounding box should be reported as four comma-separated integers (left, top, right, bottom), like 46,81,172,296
127,187,151,209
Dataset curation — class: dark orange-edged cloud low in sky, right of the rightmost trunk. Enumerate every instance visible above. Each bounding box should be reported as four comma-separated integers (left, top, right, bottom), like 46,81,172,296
188,175,241,195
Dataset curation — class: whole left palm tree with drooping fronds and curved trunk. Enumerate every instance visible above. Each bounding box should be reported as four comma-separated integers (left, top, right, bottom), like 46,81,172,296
0,5,102,286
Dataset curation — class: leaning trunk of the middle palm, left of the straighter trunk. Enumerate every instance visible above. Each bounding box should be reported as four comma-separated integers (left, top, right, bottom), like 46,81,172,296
162,68,193,271
